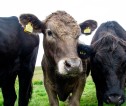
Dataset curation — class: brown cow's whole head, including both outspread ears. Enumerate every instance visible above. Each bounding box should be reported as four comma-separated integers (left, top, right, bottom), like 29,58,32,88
20,11,97,75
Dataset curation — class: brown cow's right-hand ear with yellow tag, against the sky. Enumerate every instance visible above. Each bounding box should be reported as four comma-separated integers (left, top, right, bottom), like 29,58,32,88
80,20,97,35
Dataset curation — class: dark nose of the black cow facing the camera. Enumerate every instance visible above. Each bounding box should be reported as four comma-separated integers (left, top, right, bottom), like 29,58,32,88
107,95,124,105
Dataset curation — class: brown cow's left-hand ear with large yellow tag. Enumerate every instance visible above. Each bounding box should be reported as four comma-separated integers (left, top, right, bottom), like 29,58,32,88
19,14,45,33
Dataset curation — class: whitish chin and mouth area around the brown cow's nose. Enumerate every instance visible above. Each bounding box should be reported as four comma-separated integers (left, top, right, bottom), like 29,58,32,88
57,60,83,77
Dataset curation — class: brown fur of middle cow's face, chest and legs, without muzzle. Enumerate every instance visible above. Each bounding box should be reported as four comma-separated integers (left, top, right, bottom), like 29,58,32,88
42,11,86,106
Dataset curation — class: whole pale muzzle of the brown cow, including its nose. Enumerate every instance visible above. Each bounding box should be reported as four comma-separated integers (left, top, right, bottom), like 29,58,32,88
58,58,83,76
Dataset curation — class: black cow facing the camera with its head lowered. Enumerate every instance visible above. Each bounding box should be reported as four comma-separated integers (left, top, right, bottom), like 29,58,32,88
80,21,126,106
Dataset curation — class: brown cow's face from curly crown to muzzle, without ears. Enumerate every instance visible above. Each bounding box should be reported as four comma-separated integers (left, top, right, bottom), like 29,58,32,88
43,12,82,75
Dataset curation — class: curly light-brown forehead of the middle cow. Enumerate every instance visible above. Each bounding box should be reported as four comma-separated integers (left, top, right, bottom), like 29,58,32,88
45,11,81,38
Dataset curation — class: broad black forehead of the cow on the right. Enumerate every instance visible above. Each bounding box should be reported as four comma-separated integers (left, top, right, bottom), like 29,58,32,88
93,35,126,62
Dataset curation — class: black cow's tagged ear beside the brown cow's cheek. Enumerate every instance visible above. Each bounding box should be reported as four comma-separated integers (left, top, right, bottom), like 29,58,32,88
77,44,93,59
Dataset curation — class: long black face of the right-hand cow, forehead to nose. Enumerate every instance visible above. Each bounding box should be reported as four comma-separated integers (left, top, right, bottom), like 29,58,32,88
91,36,126,104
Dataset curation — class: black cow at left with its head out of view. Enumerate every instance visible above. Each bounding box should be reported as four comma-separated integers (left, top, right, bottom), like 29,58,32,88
0,16,39,106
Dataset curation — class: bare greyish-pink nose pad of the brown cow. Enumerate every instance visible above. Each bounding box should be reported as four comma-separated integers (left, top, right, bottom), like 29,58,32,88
64,58,81,71
